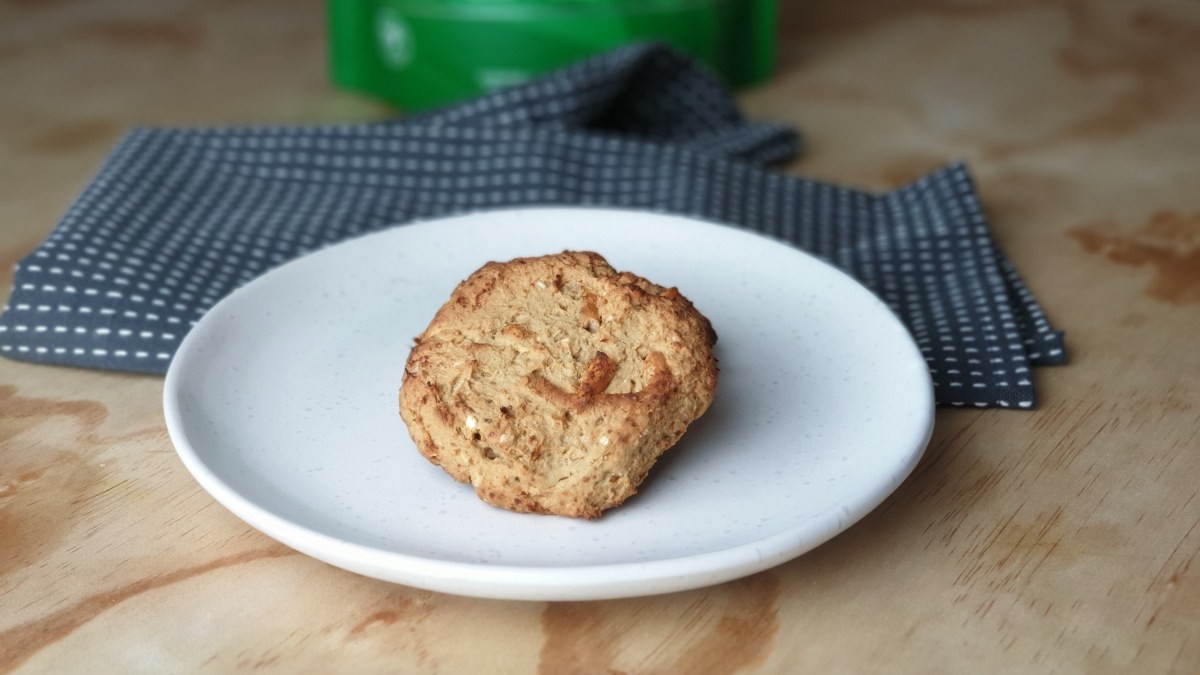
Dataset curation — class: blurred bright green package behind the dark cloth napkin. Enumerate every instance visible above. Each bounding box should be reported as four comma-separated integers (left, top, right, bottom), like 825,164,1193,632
326,0,776,112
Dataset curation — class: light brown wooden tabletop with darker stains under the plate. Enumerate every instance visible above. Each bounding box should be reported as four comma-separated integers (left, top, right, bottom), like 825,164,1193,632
0,0,1200,674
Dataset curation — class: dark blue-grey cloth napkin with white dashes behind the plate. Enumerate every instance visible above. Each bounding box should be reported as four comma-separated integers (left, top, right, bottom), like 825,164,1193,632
0,44,1063,407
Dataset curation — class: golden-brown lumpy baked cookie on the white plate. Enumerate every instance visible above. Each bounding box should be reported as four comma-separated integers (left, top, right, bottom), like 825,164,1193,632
400,251,716,518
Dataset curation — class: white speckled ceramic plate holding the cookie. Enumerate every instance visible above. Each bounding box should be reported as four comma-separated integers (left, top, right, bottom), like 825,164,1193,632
163,208,934,599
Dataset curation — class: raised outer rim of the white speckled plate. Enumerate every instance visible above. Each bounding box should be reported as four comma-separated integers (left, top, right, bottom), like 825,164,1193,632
162,205,935,601
